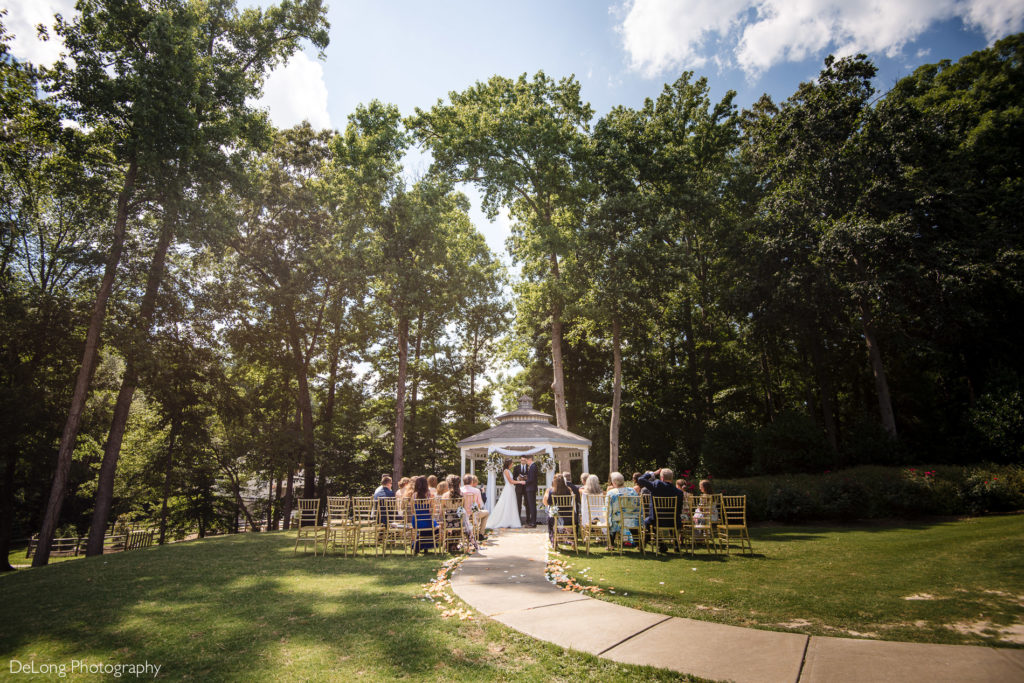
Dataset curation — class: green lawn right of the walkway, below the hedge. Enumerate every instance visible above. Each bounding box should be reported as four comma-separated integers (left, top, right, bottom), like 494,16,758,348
556,515,1024,647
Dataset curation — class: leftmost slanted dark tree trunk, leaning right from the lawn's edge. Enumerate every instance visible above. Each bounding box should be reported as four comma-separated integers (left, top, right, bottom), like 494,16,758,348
32,159,138,566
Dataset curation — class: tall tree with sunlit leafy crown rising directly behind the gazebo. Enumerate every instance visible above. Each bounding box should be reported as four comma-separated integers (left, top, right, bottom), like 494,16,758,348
409,72,593,429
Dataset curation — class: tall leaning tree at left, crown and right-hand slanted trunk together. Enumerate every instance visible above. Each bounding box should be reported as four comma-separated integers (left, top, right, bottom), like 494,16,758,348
83,0,327,555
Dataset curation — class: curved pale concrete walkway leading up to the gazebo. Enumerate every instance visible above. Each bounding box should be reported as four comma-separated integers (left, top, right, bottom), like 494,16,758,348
452,527,1024,683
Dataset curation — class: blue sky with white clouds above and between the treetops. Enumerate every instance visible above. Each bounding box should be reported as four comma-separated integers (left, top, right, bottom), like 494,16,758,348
4,0,1024,259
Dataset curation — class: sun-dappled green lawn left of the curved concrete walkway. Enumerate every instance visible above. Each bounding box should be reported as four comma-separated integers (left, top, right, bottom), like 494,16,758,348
0,532,696,681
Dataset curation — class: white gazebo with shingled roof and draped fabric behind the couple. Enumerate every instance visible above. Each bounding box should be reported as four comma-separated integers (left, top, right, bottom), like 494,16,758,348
458,395,591,510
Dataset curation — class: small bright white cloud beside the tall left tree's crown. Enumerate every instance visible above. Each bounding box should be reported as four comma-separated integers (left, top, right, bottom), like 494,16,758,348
256,52,331,128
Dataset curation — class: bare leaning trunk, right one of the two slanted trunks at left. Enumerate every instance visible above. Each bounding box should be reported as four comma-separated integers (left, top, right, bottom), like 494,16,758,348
85,209,177,557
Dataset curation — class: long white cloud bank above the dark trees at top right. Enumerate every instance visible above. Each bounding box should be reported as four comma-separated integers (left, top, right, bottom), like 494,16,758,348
618,0,1024,77
